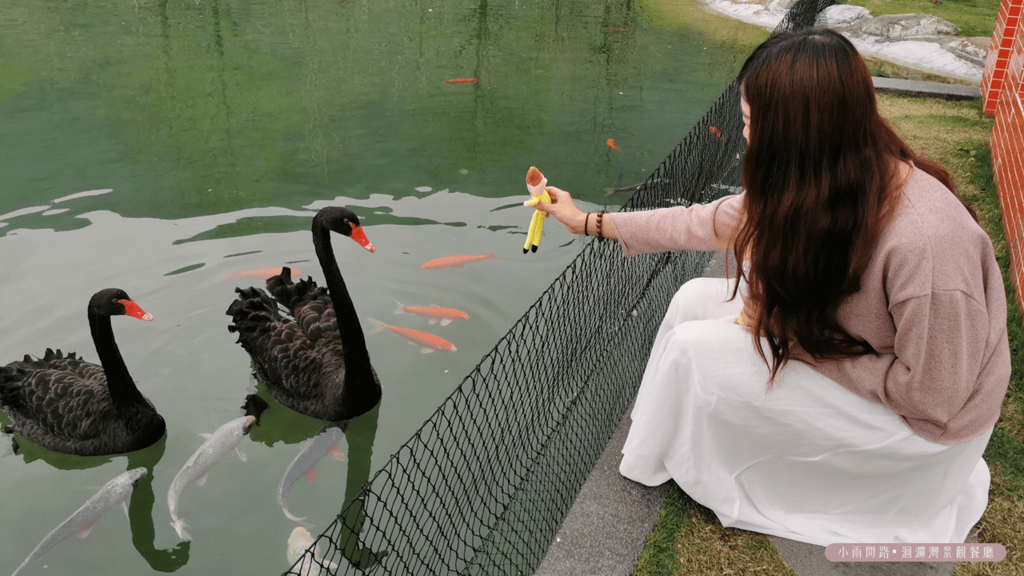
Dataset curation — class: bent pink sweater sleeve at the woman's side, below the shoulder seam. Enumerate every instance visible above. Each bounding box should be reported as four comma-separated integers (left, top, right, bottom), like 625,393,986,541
882,290,989,442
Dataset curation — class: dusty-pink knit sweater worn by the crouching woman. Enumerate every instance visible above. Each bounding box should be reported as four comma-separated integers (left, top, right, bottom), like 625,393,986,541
605,169,1010,445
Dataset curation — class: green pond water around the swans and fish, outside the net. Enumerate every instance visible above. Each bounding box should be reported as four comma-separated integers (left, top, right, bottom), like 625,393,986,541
0,0,746,575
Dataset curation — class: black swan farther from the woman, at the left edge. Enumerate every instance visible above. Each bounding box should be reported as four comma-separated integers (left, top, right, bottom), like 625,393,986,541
0,288,167,456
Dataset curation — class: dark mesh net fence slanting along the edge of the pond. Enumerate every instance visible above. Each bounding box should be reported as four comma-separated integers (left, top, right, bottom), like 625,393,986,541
286,0,830,575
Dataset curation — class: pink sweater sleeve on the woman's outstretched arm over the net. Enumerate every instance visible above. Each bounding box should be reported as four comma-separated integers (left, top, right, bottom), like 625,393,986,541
604,194,743,256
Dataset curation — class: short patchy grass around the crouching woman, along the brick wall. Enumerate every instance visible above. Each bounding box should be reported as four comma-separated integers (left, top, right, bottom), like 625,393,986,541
634,91,1024,576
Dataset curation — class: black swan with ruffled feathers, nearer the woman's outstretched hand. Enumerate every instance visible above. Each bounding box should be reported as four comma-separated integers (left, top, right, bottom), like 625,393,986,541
226,206,381,422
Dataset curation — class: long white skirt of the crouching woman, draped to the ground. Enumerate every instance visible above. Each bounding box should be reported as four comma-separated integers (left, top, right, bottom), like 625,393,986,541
620,278,992,546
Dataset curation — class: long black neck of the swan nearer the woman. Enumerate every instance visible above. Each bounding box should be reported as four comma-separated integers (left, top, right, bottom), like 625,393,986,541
313,228,372,380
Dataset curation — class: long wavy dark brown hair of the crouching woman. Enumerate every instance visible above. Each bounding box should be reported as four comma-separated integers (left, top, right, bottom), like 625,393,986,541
733,29,955,388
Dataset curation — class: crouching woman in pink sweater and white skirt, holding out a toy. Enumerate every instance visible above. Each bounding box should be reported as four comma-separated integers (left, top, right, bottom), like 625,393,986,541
538,29,1010,545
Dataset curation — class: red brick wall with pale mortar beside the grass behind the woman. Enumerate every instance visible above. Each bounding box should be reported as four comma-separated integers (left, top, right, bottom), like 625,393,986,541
983,13,1024,305
